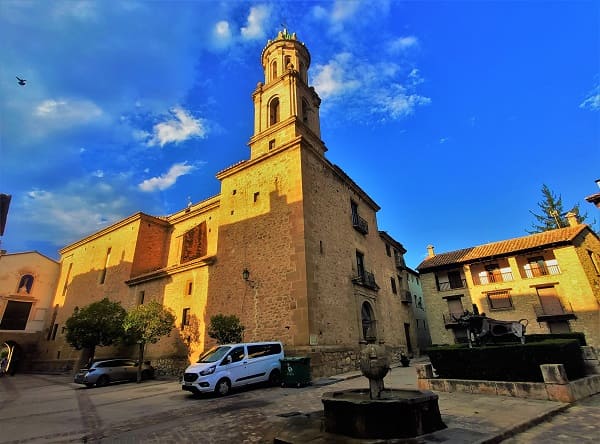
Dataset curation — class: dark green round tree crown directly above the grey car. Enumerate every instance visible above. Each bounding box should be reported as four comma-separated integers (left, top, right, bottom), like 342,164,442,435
65,298,126,361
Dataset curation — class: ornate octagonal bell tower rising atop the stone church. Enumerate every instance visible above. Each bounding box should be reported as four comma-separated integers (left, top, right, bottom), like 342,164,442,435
248,29,327,160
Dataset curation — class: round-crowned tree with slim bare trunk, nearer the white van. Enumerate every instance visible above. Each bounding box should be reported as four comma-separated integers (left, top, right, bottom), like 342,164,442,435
123,301,175,382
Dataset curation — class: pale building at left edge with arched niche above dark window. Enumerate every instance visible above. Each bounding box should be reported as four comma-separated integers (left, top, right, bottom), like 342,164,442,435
0,251,60,367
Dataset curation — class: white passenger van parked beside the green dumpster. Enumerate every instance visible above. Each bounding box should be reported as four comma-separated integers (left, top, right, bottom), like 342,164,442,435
181,342,284,396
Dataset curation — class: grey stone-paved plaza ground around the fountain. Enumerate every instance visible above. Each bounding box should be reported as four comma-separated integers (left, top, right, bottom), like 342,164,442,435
0,368,600,444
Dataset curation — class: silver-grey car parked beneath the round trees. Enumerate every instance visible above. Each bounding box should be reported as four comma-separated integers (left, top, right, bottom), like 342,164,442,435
74,359,154,387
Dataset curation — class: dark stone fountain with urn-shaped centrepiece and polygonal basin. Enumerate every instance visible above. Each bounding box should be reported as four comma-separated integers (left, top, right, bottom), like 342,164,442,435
322,343,446,439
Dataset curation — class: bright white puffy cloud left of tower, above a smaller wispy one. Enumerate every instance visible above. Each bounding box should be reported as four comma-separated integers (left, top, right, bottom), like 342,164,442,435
148,107,207,147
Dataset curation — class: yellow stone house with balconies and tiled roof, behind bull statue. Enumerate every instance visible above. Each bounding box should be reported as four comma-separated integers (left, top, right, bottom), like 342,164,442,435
417,217,600,347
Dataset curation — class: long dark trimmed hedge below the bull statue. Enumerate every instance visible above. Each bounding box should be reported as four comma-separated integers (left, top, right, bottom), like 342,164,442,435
427,339,585,382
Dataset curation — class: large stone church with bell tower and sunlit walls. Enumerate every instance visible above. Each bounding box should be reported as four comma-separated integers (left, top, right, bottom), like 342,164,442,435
35,31,419,376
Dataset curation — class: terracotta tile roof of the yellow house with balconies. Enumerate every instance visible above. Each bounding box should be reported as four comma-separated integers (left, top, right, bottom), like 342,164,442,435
417,224,589,273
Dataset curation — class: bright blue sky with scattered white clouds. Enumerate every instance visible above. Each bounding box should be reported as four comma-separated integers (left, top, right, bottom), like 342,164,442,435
0,0,600,268
